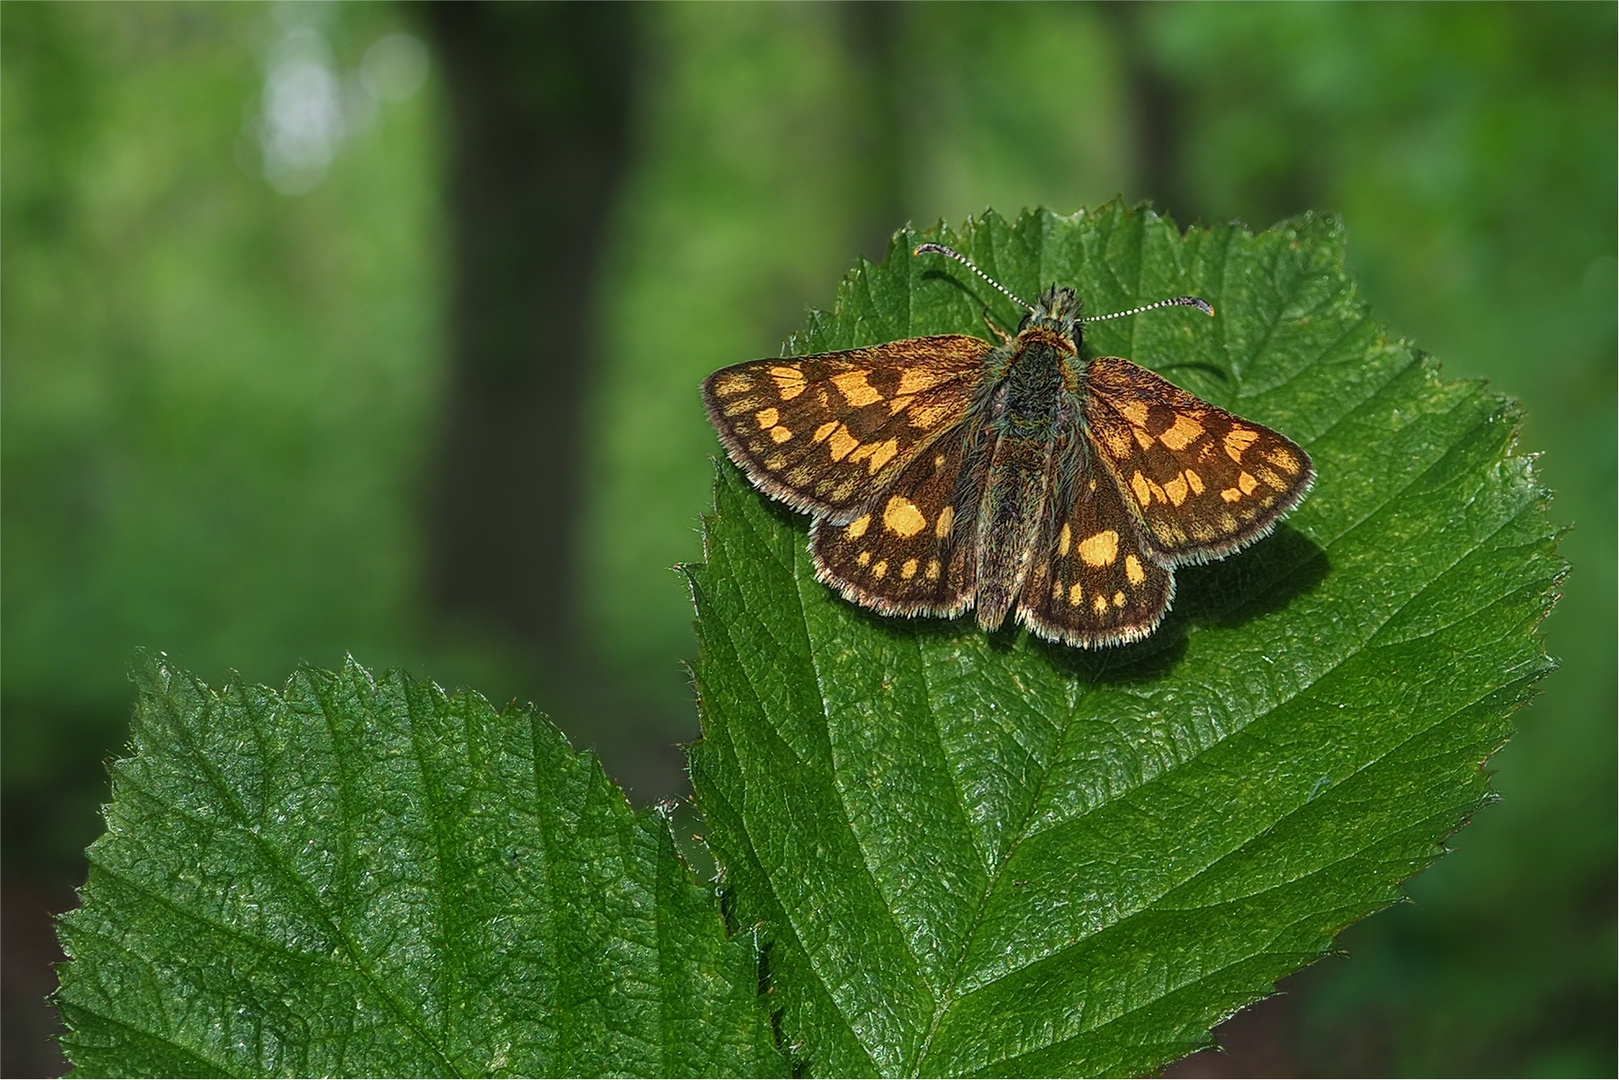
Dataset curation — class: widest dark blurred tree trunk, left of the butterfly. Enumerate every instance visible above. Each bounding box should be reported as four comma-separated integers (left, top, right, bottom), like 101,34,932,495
424,3,636,669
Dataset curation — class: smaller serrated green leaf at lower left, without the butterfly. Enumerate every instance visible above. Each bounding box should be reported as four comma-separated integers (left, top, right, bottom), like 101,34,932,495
57,657,782,1077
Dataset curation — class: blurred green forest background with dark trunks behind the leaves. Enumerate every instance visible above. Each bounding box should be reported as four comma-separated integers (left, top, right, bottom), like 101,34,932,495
0,2,1619,1075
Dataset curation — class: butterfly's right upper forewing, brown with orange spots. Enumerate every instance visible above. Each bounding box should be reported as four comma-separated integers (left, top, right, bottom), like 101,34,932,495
1085,356,1315,565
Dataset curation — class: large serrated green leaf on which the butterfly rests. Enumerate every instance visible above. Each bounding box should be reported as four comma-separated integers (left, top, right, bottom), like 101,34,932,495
690,204,1562,1075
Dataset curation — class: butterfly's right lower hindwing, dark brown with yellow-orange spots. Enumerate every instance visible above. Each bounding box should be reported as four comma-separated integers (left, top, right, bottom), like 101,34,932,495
1018,455,1175,649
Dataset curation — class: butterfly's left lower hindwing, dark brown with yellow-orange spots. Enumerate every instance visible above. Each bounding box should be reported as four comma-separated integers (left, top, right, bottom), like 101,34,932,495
810,432,978,615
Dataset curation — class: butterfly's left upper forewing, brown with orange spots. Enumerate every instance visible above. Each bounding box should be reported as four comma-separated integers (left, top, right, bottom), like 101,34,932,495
703,334,991,523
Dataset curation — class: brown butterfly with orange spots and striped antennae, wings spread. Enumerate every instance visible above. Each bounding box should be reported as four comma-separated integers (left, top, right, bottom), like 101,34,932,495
703,243,1315,648
